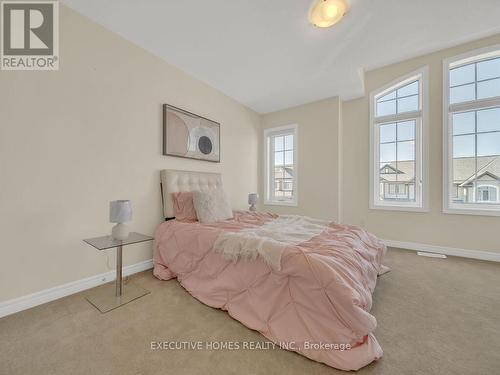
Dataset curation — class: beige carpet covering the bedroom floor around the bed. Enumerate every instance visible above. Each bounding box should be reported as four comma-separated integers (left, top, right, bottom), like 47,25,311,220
0,249,500,375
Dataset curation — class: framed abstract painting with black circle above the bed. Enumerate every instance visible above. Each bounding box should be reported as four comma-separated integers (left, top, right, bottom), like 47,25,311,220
163,104,220,163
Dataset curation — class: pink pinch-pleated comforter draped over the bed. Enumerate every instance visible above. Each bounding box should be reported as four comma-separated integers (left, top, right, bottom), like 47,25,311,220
153,212,385,370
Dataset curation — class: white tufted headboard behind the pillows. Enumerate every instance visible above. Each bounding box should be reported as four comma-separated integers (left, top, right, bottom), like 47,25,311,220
160,169,222,219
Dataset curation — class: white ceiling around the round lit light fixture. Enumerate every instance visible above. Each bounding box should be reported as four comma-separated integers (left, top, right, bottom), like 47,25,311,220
63,0,500,113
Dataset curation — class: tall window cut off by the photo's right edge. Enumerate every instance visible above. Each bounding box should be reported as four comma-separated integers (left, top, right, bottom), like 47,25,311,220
443,46,500,216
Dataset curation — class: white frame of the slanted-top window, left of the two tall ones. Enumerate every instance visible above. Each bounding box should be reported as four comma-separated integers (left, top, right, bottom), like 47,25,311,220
369,66,429,212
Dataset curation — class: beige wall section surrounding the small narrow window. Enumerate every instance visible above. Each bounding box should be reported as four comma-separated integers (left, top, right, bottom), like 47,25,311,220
260,97,341,220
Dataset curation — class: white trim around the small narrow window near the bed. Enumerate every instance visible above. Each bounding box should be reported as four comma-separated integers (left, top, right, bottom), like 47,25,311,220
263,124,299,206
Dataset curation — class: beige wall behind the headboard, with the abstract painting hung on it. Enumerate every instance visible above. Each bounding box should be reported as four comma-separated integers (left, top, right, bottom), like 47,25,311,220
0,5,260,301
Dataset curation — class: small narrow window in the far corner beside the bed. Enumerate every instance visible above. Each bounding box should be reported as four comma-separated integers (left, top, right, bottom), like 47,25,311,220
264,125,298,206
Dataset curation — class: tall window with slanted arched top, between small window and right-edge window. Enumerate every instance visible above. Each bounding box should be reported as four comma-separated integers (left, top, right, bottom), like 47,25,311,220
370,68,427,211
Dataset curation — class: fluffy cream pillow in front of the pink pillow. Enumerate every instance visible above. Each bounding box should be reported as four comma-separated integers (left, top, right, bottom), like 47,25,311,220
193,189,233,223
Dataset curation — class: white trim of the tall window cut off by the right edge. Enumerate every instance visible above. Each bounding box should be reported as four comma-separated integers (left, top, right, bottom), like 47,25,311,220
443,44,500,216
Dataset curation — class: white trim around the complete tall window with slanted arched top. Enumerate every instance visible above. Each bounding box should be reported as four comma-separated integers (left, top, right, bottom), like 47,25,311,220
369,66,429,212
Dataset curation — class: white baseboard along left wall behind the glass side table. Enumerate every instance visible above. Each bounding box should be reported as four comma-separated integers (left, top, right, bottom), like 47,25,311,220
0,259,153,318
